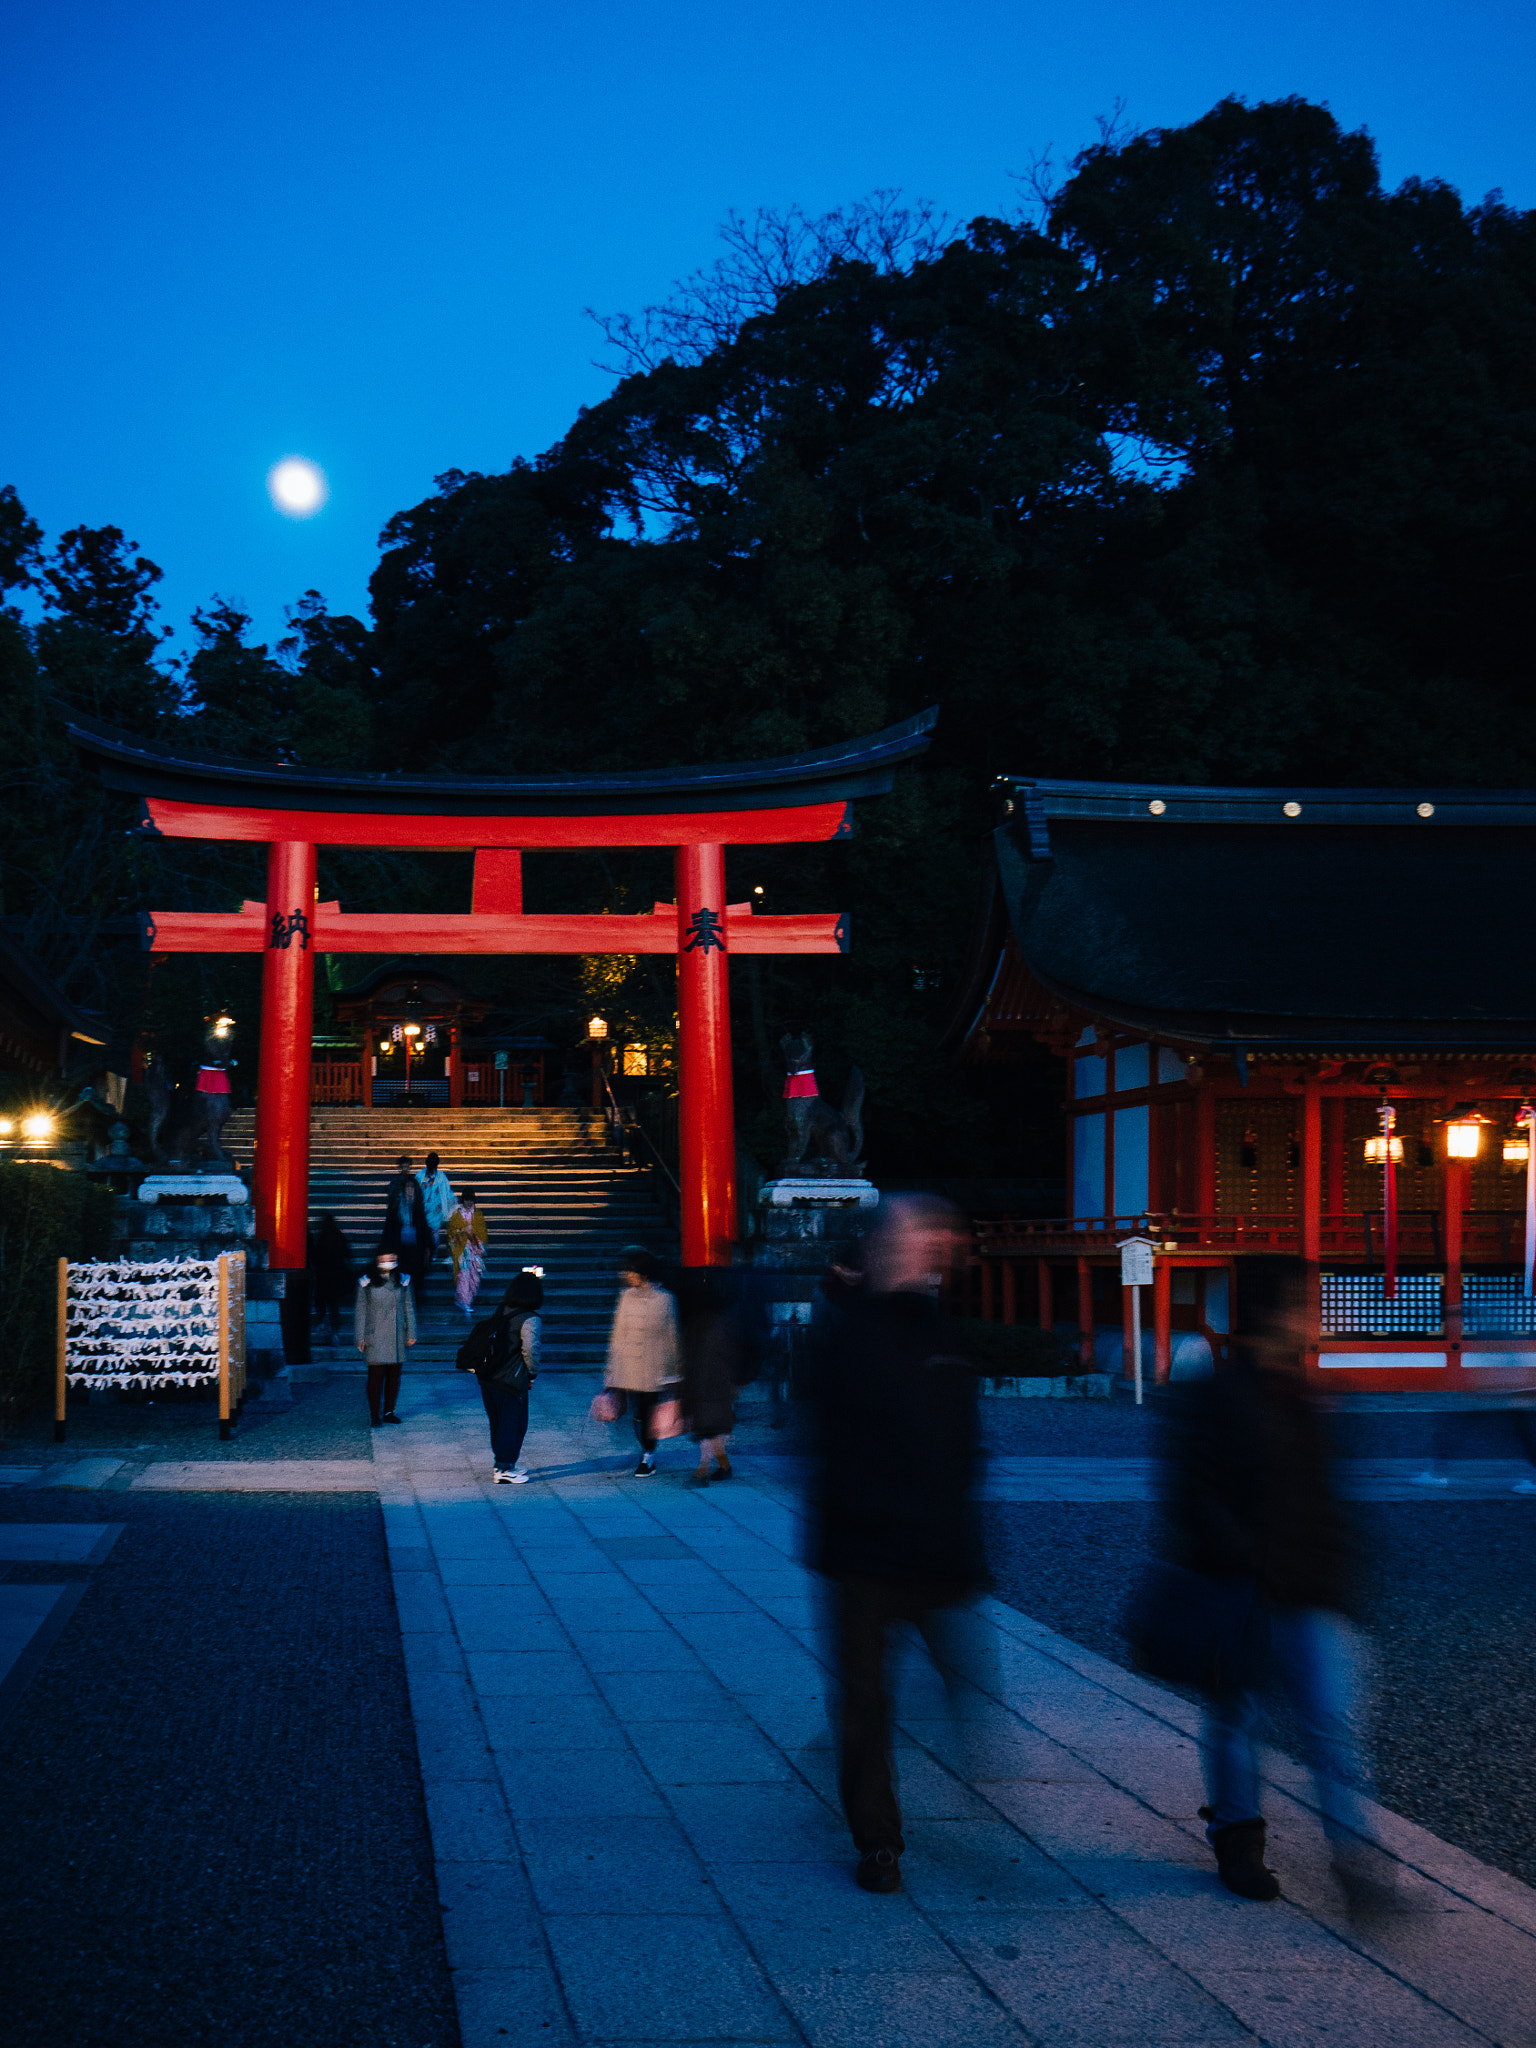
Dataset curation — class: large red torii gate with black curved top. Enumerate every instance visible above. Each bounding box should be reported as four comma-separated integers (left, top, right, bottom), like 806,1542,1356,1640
66,711,938,1268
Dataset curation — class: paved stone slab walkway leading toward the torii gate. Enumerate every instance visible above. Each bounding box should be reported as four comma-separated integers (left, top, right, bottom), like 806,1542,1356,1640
373,1376,1536,2048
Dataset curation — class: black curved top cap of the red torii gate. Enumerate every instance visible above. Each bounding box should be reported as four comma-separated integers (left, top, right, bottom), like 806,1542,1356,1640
59,707,938,817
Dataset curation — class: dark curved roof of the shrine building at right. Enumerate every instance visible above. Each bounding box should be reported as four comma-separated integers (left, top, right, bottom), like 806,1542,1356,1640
997,778,1536,1051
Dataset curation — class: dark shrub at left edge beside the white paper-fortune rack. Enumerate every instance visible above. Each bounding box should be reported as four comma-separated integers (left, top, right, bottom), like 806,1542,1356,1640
0,1161,113,1419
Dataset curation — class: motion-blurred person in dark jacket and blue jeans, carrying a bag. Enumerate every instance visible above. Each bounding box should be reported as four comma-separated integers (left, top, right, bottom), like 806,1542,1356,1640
1169,1257,1380,1907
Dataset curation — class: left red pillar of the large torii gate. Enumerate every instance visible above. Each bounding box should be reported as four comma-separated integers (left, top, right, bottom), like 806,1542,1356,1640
254,840,315,1272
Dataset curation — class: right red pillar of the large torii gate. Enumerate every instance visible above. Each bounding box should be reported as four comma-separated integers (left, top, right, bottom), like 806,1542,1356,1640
676,846,735,1266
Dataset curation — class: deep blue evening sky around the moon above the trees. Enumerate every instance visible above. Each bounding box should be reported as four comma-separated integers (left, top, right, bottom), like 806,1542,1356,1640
0,0,1536,655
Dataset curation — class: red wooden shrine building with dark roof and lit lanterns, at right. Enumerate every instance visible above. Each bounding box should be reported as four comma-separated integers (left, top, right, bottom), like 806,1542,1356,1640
961,778,1536,1393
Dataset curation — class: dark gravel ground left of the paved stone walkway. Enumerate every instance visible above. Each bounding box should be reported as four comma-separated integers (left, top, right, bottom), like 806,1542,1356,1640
0,1384,459,2048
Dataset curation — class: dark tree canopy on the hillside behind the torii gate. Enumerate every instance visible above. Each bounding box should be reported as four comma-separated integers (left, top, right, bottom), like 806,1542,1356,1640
0,100,1536,1169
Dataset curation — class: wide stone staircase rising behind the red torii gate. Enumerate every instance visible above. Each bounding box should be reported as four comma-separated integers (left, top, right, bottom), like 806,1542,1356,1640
225,1108,676,1372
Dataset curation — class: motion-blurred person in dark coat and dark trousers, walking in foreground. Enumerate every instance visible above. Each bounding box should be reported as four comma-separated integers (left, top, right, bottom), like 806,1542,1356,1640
809,1196,985,1892
